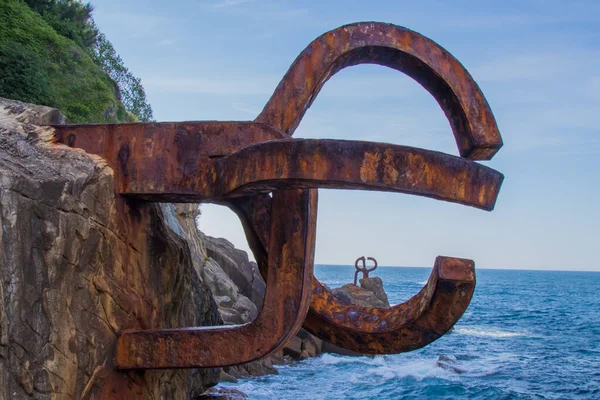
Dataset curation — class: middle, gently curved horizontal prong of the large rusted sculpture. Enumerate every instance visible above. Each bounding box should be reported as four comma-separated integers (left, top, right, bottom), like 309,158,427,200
213,139,504,210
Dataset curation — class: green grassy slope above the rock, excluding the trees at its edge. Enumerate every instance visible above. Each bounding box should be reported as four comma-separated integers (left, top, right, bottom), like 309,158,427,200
0,0,128,123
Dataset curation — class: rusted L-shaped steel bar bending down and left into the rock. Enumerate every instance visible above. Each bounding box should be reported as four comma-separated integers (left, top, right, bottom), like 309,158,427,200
115,190,317,368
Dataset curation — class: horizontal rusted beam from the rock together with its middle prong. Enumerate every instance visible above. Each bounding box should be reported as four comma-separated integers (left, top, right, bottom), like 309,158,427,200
57,130,503,210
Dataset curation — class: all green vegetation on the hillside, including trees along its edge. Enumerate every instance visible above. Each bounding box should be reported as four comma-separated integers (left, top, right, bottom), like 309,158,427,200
0,0,152,123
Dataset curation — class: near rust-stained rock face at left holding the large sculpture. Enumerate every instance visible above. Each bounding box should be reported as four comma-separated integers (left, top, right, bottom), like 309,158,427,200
0,99,219,400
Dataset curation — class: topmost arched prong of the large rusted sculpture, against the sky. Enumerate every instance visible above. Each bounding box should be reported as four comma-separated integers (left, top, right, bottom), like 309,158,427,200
256,22,502,160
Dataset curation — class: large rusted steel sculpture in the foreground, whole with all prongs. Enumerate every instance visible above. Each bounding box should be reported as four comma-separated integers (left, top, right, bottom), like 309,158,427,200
51,22,503,368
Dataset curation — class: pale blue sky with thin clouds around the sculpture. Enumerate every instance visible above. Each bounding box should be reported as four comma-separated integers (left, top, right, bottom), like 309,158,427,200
94,0,600,271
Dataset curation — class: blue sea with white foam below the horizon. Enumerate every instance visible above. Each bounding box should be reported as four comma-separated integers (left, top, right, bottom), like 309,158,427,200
220,265,600,400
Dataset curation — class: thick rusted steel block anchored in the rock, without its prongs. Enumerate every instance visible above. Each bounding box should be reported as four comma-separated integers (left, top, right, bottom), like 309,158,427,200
56,121,286,202
